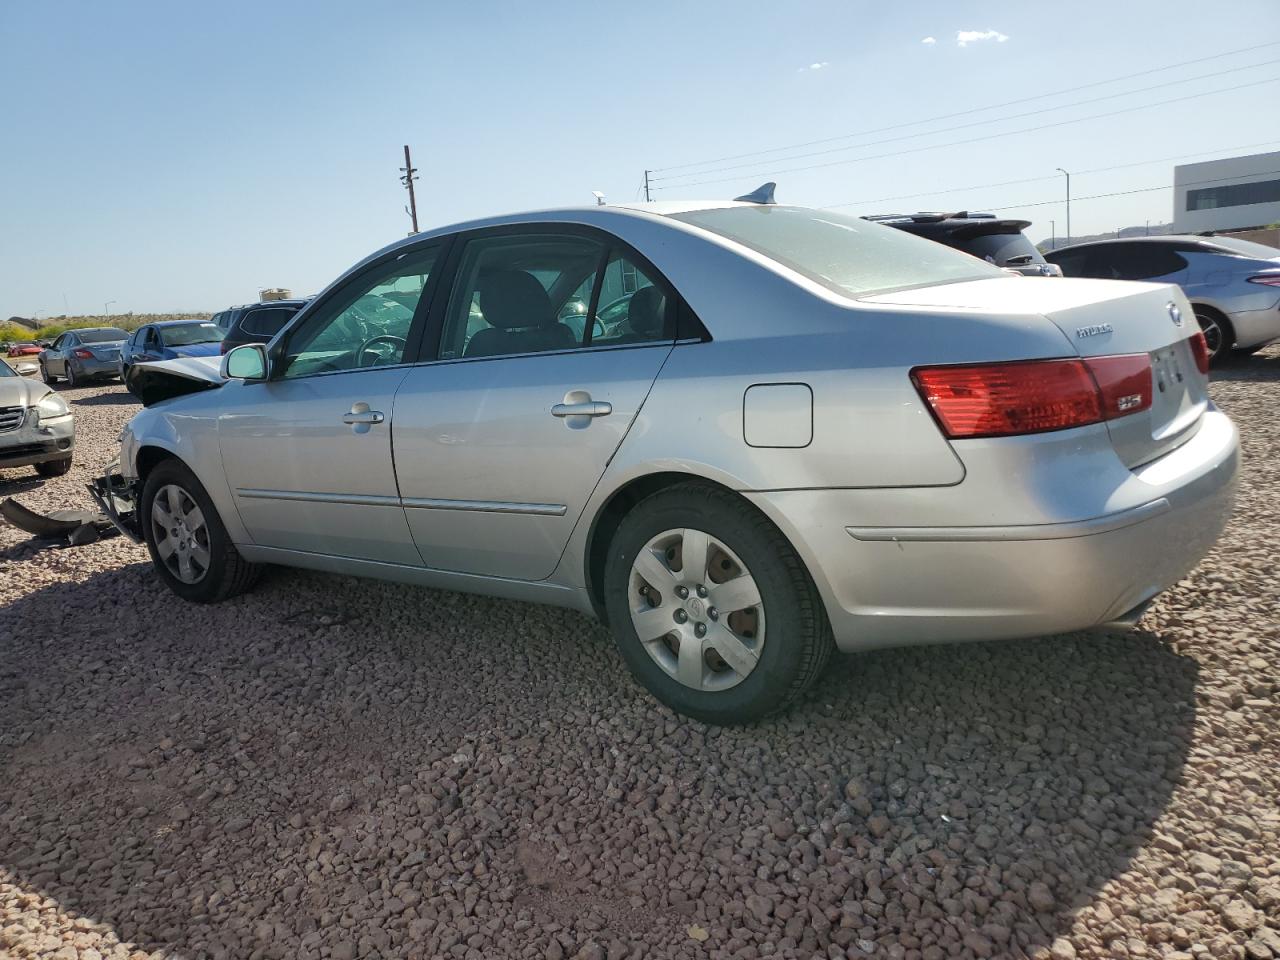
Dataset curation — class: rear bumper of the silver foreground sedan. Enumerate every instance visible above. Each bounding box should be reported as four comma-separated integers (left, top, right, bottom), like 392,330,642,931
748,411,1239,650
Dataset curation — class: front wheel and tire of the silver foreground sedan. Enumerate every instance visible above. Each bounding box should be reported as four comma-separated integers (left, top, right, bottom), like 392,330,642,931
138,460,261,603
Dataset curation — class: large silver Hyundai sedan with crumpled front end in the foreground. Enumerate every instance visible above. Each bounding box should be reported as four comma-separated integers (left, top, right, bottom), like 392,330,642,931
100,202,1238,722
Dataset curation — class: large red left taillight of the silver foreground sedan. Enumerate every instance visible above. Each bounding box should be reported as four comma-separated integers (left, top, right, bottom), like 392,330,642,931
911,353,1151,440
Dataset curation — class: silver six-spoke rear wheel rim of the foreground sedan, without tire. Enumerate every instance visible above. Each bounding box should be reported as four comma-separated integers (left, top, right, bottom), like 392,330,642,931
627,527,764,691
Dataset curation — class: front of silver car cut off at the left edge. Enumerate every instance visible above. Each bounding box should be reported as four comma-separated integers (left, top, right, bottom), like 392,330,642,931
0,360,76,476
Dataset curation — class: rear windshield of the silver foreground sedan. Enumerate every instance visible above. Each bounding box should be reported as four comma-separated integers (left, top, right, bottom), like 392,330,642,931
672,205,1004,297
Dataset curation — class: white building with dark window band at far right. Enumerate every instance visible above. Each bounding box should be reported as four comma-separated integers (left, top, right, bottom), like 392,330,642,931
1174,152,1280,233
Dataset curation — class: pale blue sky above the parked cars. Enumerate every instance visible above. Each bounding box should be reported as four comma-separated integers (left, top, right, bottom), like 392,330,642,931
0,0,1280,317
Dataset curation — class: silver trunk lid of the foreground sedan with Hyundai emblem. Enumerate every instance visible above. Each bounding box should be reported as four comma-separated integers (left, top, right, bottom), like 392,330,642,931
865,276,1208,467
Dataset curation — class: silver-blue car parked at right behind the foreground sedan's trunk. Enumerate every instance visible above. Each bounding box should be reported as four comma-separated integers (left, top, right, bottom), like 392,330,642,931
1044,236,1280,362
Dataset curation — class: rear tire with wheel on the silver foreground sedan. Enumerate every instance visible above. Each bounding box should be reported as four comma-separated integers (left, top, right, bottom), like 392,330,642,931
604,483,835,724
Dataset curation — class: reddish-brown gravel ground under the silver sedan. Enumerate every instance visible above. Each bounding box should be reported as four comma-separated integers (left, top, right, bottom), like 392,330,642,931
0,358,1280,960
